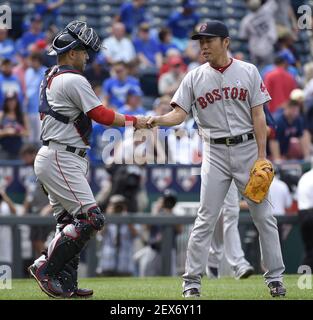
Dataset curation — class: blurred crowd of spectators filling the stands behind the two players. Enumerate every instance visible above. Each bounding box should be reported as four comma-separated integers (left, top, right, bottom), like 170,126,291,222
0,0,313,163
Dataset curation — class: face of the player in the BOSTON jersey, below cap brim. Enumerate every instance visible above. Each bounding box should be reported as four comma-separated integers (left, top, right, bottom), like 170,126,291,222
199,37,228,63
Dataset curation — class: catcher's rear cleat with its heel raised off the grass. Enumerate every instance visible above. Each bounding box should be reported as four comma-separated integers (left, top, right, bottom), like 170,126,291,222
28,264,73,298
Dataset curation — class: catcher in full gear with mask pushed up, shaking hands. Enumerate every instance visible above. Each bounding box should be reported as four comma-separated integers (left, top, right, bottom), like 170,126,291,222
29,21,146,298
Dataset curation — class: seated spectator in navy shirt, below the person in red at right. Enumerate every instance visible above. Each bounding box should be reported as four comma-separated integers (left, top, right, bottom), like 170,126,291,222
269,100,310,162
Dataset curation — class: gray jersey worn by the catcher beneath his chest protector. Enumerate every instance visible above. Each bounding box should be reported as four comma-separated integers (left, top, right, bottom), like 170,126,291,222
41,73,102,148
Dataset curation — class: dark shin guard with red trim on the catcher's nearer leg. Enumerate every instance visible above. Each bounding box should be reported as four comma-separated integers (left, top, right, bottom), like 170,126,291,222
44,207,105,276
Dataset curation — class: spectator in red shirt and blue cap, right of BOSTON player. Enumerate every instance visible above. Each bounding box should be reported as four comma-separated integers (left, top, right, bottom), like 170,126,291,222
264,53,297,113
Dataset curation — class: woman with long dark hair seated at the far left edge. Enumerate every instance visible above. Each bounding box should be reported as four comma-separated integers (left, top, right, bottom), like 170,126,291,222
0,94,29,159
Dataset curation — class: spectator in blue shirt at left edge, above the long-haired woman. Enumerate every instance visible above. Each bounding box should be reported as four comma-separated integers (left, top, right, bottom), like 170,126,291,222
0,59,23,110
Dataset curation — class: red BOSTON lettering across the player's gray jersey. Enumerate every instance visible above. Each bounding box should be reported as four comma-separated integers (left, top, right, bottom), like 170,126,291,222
197,87,248,109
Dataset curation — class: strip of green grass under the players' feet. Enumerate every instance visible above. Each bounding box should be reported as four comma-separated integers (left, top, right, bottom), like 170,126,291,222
0,275,313,300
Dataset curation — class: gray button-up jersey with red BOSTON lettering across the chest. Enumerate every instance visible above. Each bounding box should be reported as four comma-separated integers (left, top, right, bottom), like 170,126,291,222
171,59,271,139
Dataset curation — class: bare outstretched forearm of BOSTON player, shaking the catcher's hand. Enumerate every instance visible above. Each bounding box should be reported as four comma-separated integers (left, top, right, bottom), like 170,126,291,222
147,104,187,128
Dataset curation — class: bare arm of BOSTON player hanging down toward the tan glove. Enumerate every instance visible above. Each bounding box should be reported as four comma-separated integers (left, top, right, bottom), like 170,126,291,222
251,104,267,159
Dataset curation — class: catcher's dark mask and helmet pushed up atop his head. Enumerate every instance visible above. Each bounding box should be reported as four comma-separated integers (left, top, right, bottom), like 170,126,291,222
48,20,101,56
